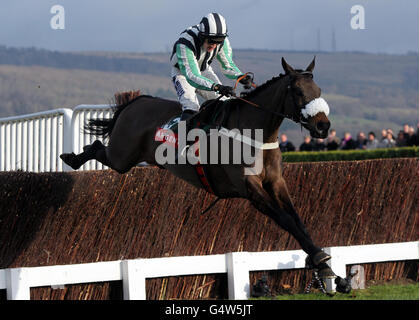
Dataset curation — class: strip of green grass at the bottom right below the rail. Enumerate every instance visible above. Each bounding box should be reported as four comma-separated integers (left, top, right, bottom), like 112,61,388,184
254,283,419,300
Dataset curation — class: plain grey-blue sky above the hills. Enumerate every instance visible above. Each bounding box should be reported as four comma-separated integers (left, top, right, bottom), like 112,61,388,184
0,0,419,54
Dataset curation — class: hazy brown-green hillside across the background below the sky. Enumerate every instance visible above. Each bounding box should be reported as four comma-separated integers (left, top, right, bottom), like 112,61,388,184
0,46,419,145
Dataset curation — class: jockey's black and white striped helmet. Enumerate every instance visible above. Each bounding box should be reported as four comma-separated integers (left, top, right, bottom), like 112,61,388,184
199,13,227,43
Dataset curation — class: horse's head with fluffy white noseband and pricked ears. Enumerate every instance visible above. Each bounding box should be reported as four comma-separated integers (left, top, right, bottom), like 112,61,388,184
282,58,330,138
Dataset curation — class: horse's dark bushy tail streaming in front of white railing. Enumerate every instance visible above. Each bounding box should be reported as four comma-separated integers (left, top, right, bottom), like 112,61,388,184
84,90,141,138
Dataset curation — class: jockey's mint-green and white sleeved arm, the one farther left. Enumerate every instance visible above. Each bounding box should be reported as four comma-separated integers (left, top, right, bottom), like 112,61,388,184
176,44,215,91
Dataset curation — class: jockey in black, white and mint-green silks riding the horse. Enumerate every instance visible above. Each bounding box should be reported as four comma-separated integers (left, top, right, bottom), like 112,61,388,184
170,13,251,121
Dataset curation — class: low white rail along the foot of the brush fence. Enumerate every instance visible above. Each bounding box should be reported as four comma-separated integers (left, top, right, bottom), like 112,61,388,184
0,241,419,300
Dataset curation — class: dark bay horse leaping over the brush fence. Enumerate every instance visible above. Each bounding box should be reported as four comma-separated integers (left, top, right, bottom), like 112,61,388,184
60,58,344,284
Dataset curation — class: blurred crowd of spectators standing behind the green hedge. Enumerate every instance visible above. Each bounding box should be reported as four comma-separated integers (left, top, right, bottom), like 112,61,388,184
279,123,419,152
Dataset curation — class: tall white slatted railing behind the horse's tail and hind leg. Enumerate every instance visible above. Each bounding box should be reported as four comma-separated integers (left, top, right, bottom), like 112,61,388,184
0,105,112,172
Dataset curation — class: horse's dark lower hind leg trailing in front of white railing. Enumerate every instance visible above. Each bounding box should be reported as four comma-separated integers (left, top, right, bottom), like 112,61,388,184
60,140,112,170
